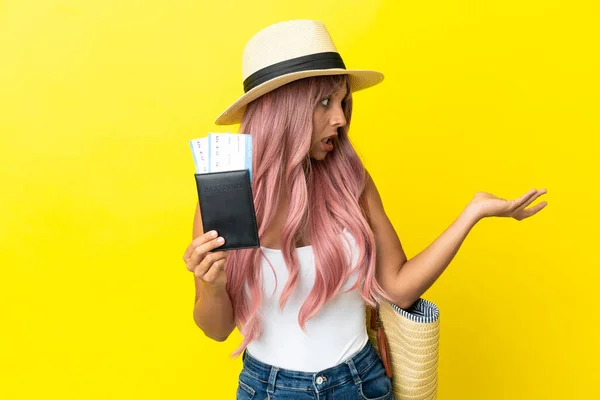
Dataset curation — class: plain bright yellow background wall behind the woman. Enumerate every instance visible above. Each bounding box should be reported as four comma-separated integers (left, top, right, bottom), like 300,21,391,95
0,0,600,400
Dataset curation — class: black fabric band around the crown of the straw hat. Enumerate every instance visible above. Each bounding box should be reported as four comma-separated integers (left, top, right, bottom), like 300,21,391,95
244,52,346,93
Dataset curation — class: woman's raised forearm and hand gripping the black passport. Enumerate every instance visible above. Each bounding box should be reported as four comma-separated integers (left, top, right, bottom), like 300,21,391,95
183,205,235,342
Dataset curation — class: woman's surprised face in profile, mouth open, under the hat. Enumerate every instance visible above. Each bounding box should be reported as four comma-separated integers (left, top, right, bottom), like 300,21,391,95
309,85,349,160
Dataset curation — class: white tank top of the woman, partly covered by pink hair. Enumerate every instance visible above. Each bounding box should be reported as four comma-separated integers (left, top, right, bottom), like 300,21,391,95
248,229,368,372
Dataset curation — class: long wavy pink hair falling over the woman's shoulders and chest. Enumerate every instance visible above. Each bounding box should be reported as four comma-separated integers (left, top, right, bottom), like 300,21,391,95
225,75,387,355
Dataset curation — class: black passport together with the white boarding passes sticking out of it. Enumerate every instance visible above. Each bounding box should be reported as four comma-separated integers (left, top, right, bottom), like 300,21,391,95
190,133,260,250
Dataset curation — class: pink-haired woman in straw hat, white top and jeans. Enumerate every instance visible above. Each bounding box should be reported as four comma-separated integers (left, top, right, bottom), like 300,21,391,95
184,20,546,400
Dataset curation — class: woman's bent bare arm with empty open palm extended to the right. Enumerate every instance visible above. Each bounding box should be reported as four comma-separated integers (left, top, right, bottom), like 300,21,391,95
365,173,547,308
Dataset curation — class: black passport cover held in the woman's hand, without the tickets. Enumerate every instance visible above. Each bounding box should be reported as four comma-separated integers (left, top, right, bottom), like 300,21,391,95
195,169,260,251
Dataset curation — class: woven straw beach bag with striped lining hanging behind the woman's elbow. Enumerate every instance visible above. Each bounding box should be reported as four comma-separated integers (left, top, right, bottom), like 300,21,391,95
367,299,440,400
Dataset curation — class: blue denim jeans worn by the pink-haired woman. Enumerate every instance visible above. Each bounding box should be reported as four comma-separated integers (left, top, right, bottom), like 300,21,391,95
236,342,394,400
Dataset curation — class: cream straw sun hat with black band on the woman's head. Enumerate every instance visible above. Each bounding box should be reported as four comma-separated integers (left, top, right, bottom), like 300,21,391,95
215,20,383,125
